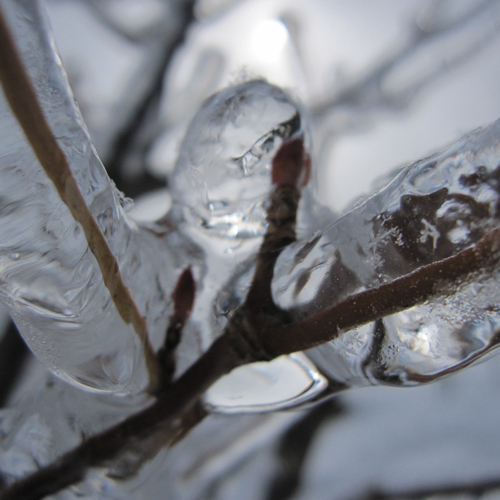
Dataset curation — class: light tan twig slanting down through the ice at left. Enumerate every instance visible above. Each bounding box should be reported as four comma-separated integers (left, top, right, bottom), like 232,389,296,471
0,6,159,390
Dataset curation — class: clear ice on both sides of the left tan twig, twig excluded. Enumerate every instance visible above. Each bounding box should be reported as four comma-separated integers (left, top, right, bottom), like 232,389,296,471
0,0,176,394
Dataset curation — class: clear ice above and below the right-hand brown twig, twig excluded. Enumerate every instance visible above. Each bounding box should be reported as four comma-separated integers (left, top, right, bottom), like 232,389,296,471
273,121,500,385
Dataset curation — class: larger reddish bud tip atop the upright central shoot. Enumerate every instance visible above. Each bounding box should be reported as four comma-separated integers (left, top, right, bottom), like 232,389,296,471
272,137,311,186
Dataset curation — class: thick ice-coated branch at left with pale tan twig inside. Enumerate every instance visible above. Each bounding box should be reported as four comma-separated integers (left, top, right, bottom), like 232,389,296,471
0,0,176,393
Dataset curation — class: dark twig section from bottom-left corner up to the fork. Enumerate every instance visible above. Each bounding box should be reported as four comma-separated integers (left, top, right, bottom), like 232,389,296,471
0,335,242,500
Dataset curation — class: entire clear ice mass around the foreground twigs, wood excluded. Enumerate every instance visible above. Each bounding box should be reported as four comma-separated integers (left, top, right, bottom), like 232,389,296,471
4,0,500,412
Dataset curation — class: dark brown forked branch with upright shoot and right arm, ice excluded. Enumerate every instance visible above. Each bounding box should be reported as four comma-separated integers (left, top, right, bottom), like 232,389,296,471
4,125,500,500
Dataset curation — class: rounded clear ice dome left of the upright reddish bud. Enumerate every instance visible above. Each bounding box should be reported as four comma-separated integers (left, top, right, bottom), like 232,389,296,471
171,80,304,238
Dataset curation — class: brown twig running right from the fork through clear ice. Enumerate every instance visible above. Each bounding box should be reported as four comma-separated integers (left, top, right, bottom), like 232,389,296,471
260,228,500,358
